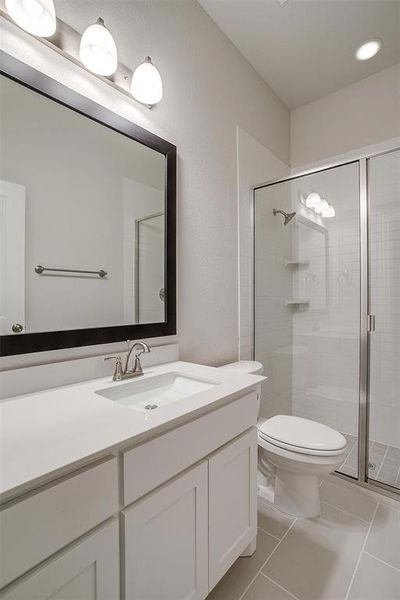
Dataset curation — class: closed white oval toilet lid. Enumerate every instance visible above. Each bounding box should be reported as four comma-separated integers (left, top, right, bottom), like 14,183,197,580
258,415,346,454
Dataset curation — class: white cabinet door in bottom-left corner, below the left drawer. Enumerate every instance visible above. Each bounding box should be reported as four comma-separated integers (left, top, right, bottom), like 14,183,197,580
0,521,119,600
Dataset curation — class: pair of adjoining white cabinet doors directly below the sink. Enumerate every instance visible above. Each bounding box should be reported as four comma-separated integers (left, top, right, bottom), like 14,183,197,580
122,428,257,600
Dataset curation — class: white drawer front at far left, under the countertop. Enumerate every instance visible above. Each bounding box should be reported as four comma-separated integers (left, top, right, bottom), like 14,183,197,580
0,457,119,587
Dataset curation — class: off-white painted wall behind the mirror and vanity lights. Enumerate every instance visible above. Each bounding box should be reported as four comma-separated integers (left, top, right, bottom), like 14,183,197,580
0,0,289,364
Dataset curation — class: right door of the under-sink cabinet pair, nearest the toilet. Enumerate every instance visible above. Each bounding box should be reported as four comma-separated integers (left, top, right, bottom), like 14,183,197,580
209,428,257,590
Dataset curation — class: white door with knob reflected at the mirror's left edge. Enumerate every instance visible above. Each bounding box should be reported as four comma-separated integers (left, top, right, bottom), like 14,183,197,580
0,179,25,335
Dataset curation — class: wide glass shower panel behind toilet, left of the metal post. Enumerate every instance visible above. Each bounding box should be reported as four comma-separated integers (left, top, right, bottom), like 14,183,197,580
254,161,360,478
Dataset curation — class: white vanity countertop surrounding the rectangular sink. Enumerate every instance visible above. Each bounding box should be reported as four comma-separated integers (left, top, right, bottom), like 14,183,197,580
0,361,264,501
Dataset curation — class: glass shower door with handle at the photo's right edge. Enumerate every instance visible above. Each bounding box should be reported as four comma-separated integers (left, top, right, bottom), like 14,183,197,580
368,151,400,489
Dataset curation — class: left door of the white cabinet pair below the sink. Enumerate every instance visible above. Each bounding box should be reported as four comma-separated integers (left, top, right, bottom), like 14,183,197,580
123,462,208,600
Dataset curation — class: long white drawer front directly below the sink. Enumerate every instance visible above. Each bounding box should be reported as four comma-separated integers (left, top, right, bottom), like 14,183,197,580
123,392,257,506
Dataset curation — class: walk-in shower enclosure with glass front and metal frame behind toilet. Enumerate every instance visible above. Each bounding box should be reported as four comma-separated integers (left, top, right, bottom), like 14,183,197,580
253,150,400,494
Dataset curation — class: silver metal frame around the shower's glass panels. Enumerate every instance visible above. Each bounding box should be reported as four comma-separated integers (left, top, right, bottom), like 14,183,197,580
250,144,400,500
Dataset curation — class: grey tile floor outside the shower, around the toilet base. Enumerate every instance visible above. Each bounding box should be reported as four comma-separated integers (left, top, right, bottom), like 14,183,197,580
207,480,400,600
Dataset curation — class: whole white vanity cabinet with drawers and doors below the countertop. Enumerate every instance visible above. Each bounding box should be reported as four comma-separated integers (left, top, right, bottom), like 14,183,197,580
0,392,258,600
